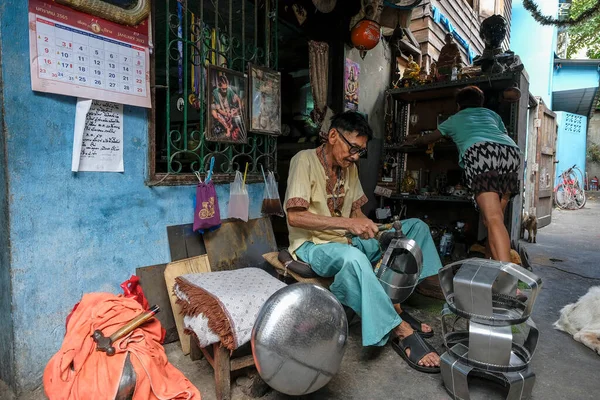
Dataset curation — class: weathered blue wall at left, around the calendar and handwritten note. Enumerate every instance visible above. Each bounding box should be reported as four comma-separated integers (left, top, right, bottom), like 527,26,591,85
0,0,263,389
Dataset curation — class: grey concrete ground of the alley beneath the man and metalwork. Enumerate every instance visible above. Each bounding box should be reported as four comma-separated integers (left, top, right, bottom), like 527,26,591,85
0,199,600,400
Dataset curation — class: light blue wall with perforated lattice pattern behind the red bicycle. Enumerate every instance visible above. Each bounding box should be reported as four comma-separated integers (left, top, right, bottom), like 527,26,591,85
554,111,587,184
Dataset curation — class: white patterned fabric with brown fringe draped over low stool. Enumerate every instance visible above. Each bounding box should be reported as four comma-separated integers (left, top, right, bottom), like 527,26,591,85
175,268,286,350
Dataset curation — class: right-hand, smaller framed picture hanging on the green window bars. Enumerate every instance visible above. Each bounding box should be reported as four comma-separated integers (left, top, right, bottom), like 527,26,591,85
248,64,281,136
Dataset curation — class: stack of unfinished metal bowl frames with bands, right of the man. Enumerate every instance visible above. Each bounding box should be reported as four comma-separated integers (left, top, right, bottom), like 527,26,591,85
439,258,542,400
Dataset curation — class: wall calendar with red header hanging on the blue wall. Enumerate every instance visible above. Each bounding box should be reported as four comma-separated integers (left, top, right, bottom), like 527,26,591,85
29,0,151,108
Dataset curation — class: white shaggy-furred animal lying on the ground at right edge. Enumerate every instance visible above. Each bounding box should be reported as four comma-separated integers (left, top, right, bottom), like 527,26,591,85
554,286,600,354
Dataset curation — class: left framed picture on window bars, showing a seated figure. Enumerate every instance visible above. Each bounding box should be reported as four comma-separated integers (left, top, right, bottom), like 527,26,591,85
206,65,248,143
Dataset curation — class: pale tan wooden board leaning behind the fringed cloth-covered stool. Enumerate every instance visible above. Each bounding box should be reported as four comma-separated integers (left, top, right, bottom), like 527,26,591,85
164,255,210,355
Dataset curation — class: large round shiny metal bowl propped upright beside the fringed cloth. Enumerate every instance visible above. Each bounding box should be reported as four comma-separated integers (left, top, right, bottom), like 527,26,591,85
251,283,348,396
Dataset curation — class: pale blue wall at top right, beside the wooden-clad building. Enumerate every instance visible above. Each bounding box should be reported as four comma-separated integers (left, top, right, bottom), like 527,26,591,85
510,0,558,107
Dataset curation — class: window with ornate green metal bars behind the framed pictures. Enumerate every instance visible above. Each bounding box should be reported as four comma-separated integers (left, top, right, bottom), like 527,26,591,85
149,0,278,185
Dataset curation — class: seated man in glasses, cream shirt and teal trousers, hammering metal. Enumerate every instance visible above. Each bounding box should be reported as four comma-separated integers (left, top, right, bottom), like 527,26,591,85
284,112,442,372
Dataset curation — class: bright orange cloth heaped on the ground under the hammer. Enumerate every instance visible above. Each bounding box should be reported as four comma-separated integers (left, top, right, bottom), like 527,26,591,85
44,293,200,400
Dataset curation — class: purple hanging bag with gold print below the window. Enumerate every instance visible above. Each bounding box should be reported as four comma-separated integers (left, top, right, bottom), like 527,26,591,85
193,157,221,233
